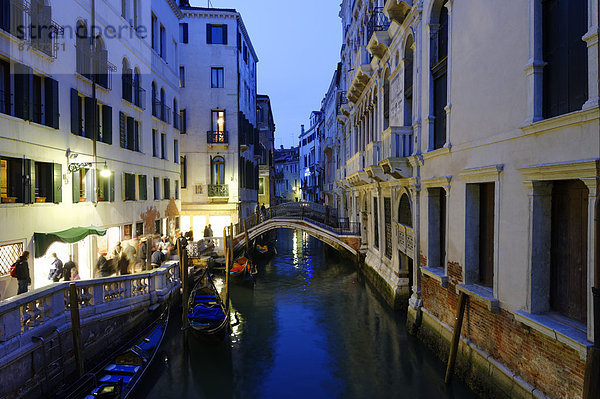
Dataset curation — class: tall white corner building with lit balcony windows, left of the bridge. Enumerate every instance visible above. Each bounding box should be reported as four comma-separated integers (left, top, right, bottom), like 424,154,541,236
178,5,260,235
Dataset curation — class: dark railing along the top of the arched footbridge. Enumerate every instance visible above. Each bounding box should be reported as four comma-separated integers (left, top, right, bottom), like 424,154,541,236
234,202,360,235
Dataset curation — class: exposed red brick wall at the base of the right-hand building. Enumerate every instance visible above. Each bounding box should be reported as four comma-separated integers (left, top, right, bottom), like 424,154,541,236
421,263,585,398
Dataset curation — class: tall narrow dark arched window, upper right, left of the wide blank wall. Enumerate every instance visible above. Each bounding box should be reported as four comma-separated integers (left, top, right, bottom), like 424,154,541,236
430,0,448,149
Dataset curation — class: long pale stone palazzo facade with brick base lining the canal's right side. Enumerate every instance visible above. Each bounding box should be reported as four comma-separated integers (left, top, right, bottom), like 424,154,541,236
330,0,600,398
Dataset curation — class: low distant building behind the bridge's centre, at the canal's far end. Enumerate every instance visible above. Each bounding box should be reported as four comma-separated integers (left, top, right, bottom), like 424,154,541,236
274,146,302,204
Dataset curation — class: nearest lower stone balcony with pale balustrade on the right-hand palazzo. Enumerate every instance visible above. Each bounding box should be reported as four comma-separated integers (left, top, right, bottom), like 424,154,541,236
379,126,413,179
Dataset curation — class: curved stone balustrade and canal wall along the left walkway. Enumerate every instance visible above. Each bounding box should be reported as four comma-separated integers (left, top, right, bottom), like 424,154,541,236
0,262,180,399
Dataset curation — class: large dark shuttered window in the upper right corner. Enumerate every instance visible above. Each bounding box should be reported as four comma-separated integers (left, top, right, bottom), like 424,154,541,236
542,0,588,118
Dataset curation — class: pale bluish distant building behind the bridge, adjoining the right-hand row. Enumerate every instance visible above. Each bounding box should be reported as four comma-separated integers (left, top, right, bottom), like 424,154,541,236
299,111,323,202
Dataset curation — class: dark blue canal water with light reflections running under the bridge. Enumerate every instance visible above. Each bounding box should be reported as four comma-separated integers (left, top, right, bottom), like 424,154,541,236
135,230,476,399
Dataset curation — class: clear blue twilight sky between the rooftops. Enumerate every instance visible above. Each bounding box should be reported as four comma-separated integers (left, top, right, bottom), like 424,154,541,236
190,0,342,148
